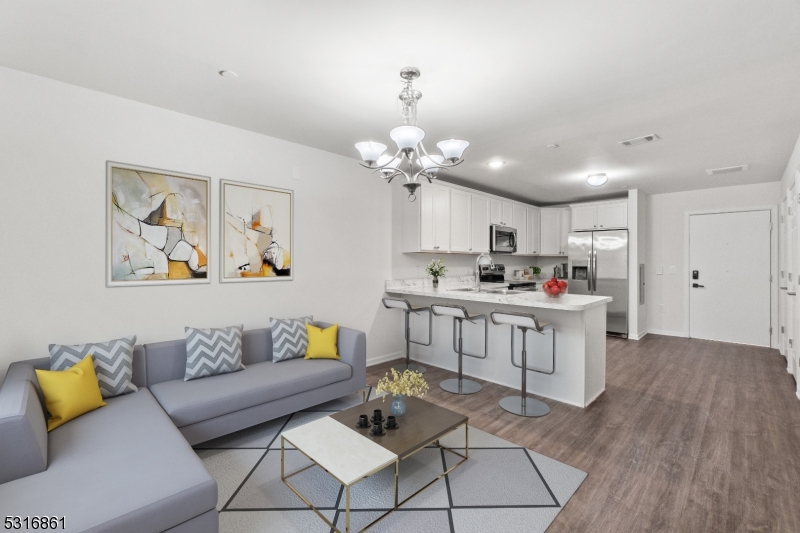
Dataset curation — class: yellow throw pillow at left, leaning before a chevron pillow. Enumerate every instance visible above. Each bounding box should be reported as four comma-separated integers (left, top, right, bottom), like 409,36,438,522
36,354,106,431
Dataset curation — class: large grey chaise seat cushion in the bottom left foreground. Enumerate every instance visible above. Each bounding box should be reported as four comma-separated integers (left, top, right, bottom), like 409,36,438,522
0,389,217,533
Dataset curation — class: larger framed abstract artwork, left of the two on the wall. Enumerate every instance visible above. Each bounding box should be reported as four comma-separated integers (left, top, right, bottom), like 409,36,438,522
106,161,211,287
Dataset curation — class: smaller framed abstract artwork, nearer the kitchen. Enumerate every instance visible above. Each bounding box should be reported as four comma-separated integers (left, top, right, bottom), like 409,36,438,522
220,180,294,282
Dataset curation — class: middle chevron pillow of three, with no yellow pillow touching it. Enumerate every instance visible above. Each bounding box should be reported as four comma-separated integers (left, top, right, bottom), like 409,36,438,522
183,326,244,381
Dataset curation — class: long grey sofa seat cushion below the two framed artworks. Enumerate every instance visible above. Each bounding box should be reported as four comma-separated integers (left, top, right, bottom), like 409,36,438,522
150,359,353,427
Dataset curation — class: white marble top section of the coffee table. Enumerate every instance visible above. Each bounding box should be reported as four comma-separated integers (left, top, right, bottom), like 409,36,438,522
282,416,397,485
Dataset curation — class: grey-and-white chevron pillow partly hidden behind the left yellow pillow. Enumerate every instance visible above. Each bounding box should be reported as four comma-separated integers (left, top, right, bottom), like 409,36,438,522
50,335,139,398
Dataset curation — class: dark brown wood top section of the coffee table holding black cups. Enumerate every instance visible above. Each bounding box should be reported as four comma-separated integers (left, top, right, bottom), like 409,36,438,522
331,395,469,459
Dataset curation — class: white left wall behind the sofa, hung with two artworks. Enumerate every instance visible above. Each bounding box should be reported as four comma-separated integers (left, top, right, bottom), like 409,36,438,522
0,68,402,378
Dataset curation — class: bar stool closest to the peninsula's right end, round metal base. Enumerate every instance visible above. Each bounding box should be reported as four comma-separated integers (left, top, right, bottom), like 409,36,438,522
492,311,556,417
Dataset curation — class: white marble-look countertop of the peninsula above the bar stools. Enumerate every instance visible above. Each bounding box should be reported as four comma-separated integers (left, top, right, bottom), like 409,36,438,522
386,278,612,311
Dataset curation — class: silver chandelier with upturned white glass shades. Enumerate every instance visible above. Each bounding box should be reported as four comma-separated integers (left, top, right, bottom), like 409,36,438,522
356,67,469,202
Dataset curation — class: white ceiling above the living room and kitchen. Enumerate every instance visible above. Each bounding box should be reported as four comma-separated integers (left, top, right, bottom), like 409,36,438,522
0,0,800,203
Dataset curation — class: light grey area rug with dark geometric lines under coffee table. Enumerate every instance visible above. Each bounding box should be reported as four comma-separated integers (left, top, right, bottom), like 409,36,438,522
195,388,586,533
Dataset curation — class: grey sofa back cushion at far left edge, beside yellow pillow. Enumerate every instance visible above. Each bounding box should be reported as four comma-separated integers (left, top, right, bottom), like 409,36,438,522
0,378,47,485
